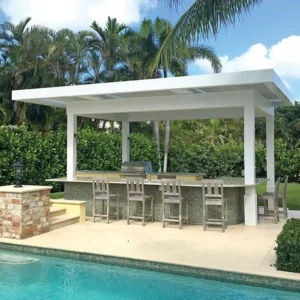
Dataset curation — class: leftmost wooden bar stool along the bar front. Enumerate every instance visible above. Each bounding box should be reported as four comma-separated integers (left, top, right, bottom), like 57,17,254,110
92,177,120,224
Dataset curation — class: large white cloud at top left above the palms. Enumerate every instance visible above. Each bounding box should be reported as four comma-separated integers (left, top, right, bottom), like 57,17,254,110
0,0,157,30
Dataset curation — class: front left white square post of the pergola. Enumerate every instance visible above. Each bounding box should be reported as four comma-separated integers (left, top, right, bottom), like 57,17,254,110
67,113,77,180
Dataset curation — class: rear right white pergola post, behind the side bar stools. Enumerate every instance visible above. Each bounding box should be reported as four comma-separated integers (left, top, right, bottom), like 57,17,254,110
266,115,275,209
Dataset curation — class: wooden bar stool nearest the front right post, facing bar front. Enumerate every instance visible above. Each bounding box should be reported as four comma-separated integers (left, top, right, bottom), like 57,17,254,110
201,180,227,232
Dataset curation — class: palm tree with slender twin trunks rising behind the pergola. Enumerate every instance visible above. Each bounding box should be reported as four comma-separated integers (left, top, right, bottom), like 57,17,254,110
141,18,222,172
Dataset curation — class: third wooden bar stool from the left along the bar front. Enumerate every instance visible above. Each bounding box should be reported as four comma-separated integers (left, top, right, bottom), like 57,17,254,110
161,179,189,229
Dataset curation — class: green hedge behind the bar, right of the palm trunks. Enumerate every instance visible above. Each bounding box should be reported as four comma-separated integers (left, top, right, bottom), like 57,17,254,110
169,139,300,181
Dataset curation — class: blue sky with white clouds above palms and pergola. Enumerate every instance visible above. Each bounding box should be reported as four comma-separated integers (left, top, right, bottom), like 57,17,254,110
0,0,300,100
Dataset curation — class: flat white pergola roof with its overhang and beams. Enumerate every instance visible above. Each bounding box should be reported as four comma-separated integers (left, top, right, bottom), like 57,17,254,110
12,70,295,122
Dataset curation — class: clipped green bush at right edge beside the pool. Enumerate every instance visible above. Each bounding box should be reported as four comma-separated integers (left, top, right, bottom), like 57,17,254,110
275,219,300,273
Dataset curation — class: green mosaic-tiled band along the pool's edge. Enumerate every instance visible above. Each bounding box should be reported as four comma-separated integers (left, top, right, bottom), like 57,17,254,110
0,242,300,293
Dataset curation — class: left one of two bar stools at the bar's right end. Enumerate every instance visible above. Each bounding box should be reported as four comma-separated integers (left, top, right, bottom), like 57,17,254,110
257,177,280,224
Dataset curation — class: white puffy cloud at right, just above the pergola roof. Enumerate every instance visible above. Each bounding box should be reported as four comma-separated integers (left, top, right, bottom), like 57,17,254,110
195,35,300,81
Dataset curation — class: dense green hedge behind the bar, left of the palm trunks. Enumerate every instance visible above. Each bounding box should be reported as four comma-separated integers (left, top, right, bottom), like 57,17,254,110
0,126,157,190
